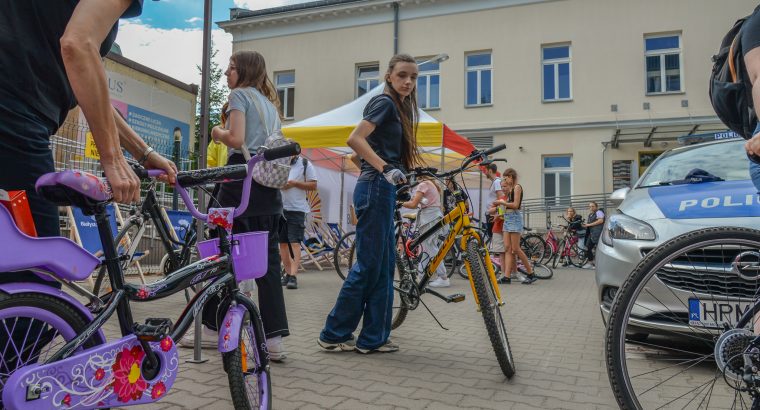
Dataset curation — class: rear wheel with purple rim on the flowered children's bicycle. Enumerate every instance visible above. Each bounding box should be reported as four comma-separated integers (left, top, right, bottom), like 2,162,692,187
0,293,102,408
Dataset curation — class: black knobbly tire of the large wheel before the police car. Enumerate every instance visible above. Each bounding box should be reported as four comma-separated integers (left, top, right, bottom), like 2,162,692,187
605,227,760,409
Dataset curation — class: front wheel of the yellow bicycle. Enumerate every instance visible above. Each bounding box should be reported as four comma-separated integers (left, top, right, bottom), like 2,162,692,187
467,238,515,378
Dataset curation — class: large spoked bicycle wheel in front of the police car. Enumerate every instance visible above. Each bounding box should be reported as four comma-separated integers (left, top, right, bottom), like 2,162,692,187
605,227,760,409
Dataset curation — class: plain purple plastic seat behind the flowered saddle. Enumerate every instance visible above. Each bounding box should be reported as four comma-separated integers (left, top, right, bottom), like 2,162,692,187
0,205,100,280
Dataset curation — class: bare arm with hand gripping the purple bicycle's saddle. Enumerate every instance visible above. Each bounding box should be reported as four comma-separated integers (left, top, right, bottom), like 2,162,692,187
61,0,140,202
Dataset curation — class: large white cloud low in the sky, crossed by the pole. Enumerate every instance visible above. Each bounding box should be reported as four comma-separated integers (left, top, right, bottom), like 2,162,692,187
116,20,232,85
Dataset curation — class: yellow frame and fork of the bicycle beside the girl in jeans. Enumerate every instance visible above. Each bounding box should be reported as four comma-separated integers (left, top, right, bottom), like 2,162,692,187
416,200,504,308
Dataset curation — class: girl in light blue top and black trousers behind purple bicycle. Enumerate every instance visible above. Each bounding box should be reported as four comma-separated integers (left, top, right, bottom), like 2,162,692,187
211,51,290,361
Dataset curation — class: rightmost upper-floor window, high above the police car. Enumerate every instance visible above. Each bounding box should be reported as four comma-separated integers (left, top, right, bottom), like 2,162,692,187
644,35,683,94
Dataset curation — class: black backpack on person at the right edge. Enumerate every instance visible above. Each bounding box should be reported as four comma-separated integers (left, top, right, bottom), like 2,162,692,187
710,12,757,139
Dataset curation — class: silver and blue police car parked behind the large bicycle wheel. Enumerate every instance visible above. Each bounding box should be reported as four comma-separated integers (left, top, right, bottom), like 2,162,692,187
596,139,760,337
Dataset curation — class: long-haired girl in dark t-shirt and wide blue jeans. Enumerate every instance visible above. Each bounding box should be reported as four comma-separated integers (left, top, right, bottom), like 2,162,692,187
318,54,422,353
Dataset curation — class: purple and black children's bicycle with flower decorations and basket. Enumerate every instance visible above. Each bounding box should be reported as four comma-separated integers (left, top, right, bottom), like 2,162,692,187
0,144,300,409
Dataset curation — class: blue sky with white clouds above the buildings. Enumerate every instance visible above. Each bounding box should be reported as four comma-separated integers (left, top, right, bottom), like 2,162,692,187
116,0,307,85
